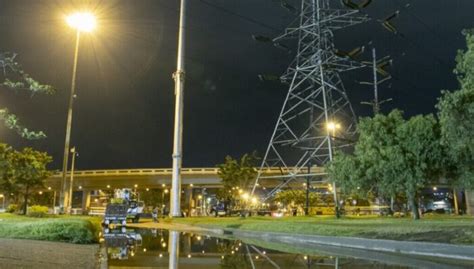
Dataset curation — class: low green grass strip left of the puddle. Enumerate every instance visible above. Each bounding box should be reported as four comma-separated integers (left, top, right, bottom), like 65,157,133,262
0,213,100,244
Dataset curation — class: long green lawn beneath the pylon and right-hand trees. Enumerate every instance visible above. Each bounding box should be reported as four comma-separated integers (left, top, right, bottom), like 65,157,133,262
168,216,474,245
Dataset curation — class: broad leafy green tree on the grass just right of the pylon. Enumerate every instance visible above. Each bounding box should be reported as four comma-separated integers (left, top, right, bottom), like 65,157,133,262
328,110,444,219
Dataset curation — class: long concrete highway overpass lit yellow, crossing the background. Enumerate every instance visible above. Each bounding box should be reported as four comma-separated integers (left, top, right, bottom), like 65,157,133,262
45,167,330,213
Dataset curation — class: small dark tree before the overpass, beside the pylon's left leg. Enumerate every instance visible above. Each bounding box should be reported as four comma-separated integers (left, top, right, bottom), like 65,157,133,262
217,152,258,201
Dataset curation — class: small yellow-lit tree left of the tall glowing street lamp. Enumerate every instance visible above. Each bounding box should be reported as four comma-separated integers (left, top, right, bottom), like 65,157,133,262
11,148,52,214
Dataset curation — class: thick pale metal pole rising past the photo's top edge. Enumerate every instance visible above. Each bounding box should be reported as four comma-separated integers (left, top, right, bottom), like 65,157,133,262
170,0,187,217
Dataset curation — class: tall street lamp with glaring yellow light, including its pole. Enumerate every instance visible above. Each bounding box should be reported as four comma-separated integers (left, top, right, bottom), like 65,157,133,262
60,12,97,207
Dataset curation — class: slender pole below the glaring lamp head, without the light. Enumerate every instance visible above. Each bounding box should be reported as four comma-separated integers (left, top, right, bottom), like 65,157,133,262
59,30,81,208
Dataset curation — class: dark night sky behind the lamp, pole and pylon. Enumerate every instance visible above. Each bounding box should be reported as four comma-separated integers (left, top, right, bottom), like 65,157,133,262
0,0,474,169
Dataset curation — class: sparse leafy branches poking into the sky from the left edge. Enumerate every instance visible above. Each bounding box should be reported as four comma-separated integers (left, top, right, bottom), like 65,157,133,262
0,52,55,139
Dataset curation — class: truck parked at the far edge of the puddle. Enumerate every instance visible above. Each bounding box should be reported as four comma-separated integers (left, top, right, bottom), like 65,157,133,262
104,189,145,226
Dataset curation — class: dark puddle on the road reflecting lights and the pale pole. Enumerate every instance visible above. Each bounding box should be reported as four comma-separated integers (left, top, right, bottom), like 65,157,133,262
104,229,473,269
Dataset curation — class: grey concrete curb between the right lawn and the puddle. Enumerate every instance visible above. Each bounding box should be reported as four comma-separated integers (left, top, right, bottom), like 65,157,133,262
224,229,474,262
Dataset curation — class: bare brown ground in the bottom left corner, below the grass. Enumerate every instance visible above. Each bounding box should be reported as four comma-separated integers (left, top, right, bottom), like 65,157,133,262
0,239,99,269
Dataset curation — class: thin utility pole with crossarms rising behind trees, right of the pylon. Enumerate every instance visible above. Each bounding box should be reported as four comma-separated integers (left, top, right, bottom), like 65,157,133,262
360,48,392,116
